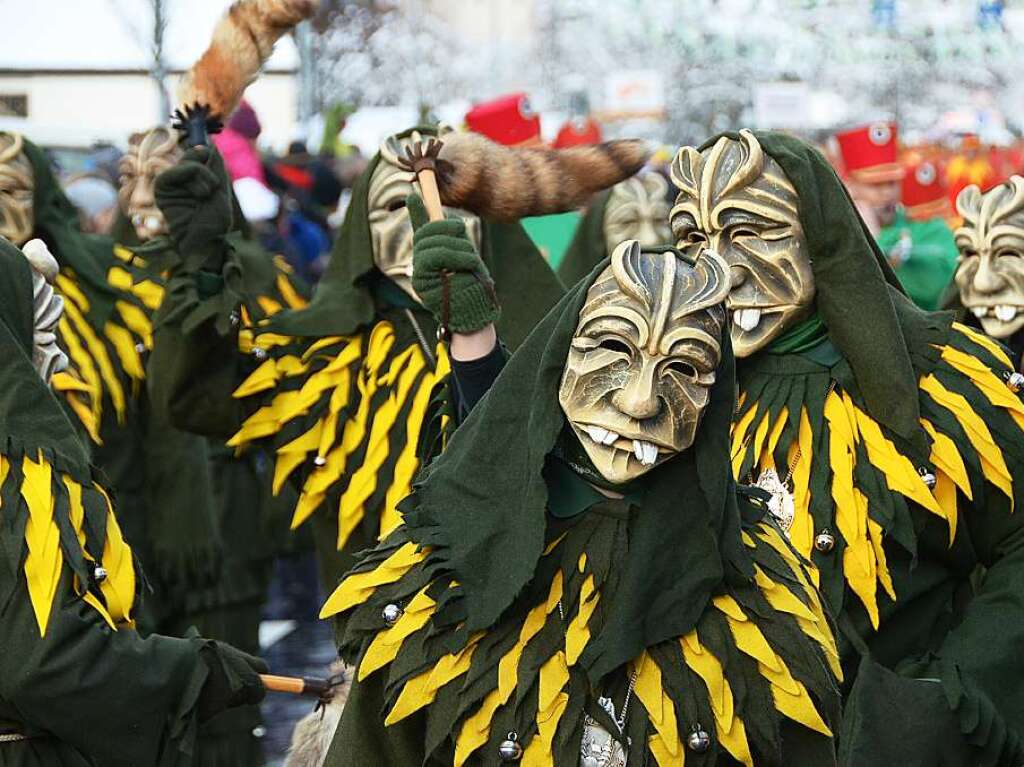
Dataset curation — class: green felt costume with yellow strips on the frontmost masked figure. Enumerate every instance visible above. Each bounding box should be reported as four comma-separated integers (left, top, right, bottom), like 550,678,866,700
323,262,839,767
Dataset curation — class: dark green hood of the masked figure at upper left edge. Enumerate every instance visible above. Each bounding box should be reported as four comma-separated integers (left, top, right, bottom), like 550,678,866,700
25,138,116,328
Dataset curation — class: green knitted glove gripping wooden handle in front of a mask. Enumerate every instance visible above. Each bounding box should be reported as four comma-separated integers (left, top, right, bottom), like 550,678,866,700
406,193,501,333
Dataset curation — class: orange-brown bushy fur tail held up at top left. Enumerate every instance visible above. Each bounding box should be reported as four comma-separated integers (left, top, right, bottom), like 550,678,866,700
178,0,317,122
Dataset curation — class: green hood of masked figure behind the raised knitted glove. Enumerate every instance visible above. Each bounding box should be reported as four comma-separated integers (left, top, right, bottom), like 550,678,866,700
270,127,563,348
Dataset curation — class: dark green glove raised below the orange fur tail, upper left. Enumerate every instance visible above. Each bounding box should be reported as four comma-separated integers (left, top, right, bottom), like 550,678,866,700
155,146,232,272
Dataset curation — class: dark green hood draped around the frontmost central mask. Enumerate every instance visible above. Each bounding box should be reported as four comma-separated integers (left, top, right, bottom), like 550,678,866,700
401,253,753,679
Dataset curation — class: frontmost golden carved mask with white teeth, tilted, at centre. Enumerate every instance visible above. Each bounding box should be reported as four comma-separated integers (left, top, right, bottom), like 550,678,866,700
558,240,729,484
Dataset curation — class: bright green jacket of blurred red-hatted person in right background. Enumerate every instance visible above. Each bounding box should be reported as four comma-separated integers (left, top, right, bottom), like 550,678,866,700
878,208,956,311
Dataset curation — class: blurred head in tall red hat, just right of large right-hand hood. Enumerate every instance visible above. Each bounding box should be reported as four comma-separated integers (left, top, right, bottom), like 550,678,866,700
836,122,903,231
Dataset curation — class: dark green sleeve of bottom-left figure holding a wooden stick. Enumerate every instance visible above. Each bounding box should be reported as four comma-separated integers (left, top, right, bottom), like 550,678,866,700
0,567,208,767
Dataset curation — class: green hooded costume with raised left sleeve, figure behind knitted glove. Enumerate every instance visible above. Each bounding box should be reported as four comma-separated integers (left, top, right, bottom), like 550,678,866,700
151,131,561,586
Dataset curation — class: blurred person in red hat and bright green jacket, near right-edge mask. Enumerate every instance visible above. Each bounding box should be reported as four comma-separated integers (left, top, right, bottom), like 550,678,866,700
877,158,956,310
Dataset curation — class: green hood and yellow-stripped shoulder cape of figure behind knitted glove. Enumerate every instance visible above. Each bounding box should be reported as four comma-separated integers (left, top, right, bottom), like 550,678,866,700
222,128,562,551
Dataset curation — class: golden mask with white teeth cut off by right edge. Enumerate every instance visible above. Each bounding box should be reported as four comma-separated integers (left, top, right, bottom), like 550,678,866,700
954,176,1024,338
